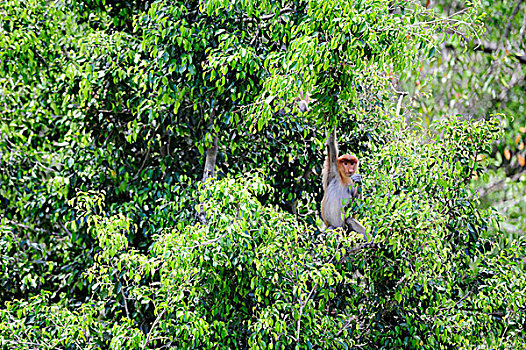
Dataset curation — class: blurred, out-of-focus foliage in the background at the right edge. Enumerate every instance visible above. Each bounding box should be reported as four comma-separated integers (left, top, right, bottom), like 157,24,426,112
401,0,526,237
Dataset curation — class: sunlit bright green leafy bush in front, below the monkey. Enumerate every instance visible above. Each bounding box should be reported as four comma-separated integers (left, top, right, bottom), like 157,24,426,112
2,118,526,349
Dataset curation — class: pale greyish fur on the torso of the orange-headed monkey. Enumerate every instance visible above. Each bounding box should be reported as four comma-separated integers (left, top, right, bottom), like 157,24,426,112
322,179,351,227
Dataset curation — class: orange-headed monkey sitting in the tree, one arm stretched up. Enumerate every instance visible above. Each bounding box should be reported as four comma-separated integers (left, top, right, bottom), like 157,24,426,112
321,128,365,238
